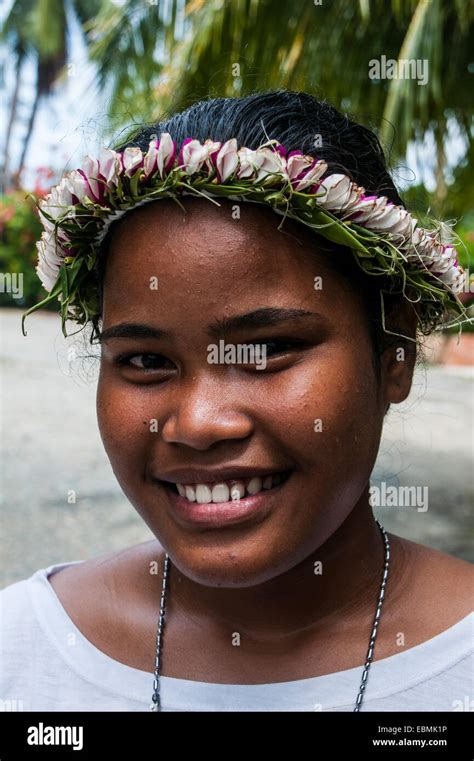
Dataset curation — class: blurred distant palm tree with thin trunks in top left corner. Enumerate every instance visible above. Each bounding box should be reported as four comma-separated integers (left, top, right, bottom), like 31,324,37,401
1,0,101,188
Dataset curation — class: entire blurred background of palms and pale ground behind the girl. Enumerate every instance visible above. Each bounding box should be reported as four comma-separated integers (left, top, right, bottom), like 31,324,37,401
0,0,474,586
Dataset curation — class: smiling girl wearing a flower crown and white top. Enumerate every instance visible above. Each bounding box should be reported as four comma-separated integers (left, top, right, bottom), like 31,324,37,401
1,91,473,711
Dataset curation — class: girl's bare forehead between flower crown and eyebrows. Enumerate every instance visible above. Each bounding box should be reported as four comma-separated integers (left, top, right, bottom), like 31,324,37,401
100,197,352,319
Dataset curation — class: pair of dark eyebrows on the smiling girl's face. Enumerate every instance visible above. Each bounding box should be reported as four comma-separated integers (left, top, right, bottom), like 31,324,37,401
100,307,324,343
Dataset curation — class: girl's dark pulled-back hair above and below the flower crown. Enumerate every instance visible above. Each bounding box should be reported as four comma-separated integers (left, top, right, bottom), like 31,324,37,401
94,90,414,375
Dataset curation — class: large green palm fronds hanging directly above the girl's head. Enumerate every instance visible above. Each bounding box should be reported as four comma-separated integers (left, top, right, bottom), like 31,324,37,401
90,0,474,215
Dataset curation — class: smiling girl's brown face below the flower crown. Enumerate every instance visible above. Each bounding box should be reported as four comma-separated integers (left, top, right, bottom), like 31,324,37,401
97,199,411,587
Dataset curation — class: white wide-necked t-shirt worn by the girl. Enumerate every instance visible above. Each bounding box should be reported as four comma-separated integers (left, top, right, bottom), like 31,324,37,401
0,560,474,711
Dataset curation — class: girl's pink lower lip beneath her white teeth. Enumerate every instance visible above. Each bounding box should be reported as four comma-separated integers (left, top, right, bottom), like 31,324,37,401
161,470,293,528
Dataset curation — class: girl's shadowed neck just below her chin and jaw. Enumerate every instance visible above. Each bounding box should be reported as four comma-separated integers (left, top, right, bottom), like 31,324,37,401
168,486,394,640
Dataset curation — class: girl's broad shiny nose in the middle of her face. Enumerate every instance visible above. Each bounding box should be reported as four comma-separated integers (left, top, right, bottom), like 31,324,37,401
161,372,253,450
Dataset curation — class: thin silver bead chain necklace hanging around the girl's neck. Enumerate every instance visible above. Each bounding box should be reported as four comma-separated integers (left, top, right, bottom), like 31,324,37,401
150,519,390,711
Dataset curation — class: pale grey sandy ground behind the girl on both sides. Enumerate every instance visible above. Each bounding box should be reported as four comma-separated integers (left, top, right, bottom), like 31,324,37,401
0,309,474,587
